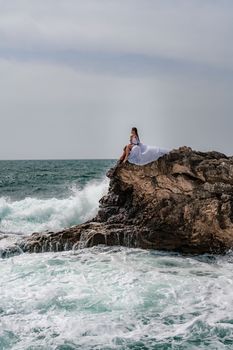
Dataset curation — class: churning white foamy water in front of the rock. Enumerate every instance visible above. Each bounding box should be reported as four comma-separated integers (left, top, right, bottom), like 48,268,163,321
0,247,233,350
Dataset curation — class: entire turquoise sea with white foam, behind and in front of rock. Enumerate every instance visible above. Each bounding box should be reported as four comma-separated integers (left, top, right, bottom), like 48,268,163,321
0,160,233,350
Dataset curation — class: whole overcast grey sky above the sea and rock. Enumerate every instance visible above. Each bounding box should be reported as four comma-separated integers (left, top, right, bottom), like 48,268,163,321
0,0,233,159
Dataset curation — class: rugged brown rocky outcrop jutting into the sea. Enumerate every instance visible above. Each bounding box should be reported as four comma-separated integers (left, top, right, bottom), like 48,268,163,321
3,147,233,255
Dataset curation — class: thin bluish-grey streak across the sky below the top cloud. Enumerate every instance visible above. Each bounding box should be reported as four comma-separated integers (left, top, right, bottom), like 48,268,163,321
0,49,233,81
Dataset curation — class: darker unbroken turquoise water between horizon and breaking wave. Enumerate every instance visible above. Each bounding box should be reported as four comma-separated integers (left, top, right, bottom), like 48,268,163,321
0,160,115,200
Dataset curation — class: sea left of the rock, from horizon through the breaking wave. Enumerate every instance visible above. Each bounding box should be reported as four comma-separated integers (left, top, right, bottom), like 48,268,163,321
0,160,115,234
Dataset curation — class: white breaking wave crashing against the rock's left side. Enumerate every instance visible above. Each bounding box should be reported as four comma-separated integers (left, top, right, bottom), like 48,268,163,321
0,178,109,234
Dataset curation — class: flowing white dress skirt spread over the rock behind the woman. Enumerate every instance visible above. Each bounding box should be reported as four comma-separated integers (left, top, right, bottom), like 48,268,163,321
128,142,169,165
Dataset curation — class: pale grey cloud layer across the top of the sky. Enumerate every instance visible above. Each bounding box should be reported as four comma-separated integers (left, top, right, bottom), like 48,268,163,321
0,0,233,68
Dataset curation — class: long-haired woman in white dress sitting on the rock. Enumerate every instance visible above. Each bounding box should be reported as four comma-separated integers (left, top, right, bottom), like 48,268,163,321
119,128,169,165
